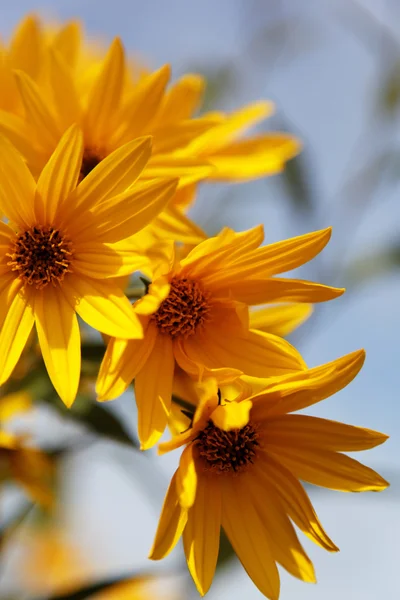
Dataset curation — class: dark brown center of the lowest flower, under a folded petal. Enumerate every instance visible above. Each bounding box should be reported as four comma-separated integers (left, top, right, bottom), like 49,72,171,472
195,421,259,473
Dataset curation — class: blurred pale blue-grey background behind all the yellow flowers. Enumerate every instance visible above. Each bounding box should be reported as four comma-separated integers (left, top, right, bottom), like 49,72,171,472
0,0,400,600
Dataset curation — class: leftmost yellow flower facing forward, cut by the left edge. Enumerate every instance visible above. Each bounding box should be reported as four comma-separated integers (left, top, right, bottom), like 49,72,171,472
0,126,177,406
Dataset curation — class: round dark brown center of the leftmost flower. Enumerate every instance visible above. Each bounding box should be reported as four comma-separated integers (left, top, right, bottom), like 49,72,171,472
7,226,72,289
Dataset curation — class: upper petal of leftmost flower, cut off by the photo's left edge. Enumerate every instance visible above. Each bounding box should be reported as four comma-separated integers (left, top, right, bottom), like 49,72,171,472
0,137,36,229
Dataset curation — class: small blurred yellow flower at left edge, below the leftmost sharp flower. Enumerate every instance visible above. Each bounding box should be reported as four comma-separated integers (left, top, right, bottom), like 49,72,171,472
0,391,54,508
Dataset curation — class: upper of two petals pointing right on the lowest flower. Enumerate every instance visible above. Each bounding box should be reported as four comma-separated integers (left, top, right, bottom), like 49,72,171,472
265,415,388,452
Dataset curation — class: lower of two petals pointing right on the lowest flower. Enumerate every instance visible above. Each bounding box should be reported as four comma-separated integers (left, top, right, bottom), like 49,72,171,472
268,446,389,492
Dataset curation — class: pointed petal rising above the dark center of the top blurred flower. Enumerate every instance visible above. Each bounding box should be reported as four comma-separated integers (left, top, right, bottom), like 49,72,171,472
84,38,123,145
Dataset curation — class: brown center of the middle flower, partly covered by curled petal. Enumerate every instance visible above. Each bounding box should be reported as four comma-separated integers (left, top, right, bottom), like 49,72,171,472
153,277,210,338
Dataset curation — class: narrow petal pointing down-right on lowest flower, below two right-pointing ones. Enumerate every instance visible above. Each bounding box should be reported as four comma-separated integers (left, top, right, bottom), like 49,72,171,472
254,455,339,552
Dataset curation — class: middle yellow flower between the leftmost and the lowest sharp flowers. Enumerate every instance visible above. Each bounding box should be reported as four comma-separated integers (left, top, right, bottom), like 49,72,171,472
96,226,343,449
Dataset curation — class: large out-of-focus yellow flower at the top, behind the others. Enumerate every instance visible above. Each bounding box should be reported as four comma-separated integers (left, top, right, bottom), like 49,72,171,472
0,21,300,243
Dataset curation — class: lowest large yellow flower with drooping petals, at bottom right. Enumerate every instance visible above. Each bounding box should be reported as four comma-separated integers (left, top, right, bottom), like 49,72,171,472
150,351,388,600
